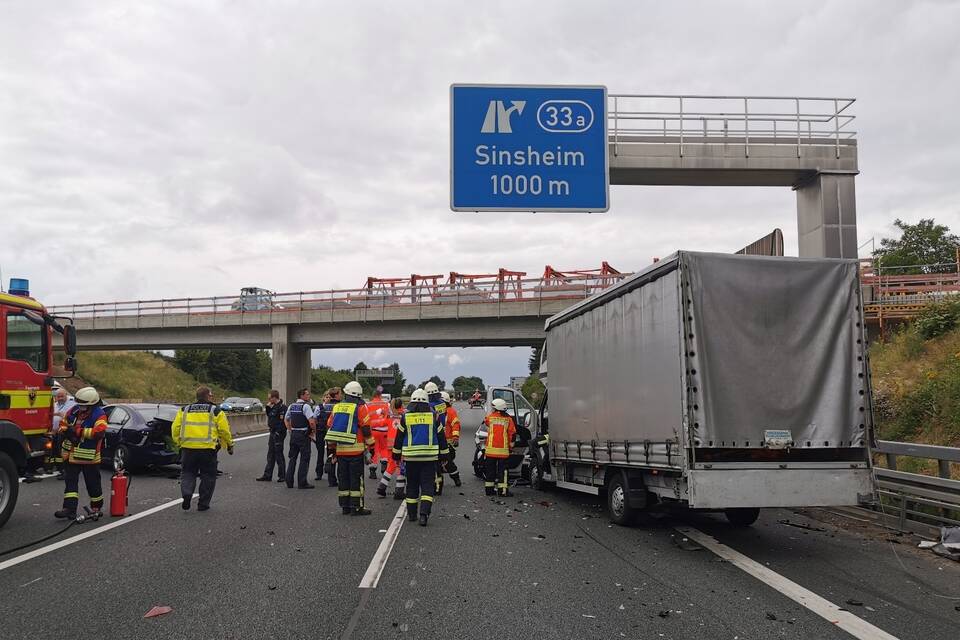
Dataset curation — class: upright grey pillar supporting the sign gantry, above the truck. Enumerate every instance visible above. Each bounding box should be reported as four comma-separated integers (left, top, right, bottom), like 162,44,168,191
796,173,857,258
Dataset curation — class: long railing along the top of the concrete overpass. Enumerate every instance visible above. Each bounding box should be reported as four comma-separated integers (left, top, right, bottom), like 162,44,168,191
49,273,630,320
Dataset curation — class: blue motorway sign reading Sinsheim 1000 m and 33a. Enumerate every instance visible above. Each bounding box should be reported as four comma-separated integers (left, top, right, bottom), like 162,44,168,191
450,85,610,212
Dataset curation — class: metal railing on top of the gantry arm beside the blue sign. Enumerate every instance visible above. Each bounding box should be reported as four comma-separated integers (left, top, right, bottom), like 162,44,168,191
607,94,857,158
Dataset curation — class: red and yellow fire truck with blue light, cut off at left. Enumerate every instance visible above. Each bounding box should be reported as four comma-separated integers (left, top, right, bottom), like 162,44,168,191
0,278,77,527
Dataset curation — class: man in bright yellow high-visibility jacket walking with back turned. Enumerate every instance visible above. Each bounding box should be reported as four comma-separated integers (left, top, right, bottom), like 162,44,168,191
170,387,233,511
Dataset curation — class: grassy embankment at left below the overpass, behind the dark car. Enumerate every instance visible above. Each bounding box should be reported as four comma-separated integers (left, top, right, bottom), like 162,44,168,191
64,351,267,402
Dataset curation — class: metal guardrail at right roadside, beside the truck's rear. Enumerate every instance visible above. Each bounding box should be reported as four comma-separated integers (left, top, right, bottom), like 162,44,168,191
868,440,960,531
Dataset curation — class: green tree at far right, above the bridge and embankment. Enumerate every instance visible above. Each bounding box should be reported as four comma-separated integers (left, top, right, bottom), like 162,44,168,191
873,218,960,274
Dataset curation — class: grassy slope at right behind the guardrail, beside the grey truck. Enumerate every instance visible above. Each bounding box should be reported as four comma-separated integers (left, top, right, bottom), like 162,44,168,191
870,325,960,478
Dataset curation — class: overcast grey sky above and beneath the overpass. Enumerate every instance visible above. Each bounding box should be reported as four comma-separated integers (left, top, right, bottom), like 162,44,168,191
0,0,960,381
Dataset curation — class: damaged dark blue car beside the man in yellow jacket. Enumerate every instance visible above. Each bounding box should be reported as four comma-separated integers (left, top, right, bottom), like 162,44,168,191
102,404,180,471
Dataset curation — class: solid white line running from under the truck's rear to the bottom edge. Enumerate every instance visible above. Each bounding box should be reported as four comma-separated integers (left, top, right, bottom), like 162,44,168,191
676,527,897,640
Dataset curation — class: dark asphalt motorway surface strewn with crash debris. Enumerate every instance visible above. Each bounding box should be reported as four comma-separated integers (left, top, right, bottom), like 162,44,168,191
0,405,960,640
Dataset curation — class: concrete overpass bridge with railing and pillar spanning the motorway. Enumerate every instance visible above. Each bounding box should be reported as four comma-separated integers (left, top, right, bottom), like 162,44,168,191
50,263,628,398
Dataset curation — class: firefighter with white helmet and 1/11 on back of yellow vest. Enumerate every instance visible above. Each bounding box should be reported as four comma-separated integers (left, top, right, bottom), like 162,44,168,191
392,389,447,527
